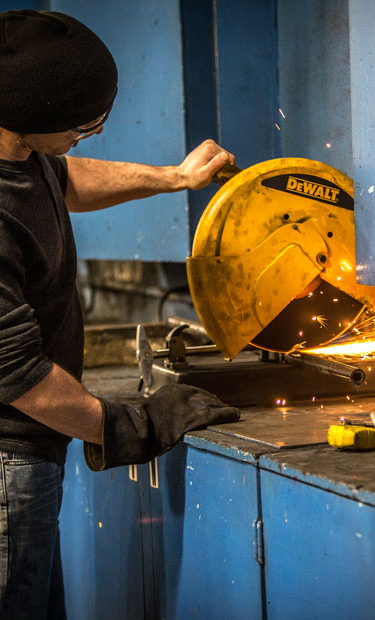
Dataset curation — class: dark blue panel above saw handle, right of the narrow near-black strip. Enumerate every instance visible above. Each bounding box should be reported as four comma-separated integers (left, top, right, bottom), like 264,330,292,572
214,0,279,167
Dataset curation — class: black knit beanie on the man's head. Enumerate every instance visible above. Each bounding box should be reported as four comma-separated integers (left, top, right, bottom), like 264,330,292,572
0,10,117,133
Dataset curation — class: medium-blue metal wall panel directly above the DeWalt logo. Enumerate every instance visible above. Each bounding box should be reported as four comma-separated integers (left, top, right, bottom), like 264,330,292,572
278,0,354,176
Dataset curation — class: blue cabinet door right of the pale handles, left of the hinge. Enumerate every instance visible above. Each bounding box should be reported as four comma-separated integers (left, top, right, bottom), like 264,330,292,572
151,444,262,620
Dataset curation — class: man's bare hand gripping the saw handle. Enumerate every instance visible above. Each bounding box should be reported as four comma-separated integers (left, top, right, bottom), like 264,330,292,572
178,140,236,189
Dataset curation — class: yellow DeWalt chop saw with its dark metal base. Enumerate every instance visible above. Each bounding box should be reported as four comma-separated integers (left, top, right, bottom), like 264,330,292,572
137,158,375,406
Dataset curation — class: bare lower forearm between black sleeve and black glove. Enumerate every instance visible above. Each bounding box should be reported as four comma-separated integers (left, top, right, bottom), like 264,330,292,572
11,364,103,444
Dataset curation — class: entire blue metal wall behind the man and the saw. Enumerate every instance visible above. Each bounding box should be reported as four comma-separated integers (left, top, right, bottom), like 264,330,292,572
0,0,368,268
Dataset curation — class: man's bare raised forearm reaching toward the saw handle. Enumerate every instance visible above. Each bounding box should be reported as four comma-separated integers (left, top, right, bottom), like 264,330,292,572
65,157,184,211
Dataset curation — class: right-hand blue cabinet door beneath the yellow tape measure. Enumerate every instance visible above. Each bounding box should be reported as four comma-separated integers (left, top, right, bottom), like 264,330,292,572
260,471,375,620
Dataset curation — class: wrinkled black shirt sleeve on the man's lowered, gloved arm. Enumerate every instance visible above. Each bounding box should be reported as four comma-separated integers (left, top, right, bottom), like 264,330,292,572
0,217,52,404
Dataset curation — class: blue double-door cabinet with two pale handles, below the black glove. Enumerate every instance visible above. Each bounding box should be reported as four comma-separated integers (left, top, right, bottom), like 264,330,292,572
61,441,263,620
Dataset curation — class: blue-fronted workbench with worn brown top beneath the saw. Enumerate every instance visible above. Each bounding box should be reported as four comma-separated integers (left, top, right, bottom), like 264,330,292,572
61,367,375,620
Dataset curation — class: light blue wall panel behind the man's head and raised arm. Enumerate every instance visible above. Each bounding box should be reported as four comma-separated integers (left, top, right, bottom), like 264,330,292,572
51,0,189,261
